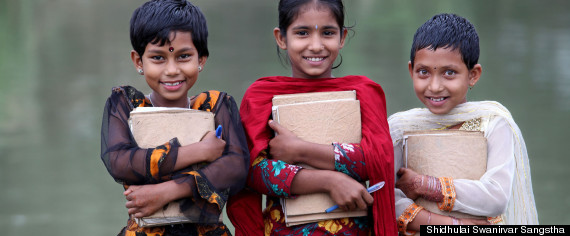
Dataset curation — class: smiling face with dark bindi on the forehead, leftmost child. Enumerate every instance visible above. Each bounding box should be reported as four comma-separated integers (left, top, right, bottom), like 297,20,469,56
131,31,207,107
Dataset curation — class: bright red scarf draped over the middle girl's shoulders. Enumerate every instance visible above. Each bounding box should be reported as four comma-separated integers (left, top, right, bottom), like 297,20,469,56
227,76,397,236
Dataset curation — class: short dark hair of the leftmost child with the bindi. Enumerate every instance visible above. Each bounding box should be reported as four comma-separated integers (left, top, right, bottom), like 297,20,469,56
130,0,209,57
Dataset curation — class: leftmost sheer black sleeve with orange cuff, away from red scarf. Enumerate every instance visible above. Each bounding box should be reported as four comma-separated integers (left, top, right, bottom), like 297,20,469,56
101,90,176,185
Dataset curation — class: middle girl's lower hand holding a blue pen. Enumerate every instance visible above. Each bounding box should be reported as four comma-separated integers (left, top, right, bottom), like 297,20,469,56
329,172,374,211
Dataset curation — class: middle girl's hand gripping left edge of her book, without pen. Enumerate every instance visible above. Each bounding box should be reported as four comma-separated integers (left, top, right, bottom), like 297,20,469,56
268,120,305,164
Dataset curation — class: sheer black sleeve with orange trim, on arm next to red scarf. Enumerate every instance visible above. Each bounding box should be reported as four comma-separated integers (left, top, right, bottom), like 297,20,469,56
169,96,249,222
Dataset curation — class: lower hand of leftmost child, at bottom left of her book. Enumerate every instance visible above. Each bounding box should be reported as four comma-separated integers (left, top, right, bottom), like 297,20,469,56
123,184,170,218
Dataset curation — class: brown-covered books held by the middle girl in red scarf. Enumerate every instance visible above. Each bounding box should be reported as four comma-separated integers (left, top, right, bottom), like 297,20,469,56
272,91,367,226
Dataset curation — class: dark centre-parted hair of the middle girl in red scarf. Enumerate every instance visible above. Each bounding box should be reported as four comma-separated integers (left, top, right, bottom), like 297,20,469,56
277,0,347,69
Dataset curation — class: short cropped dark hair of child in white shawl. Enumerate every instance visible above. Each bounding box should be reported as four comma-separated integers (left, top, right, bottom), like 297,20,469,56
410,13,479,70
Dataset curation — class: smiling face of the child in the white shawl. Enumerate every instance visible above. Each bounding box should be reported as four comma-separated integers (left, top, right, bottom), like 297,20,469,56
408,48,481,114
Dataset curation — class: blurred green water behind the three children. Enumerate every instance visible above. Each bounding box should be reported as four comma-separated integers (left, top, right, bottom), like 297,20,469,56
0,0,570,235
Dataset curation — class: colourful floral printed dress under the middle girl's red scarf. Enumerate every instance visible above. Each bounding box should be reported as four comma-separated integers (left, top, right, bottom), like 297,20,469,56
251,143,370,235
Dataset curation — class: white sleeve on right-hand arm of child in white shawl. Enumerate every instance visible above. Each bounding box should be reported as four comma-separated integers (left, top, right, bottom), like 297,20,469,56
453,117,516,217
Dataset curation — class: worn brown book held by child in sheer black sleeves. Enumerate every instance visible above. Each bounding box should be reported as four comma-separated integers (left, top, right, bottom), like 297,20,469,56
129,107,222,227
